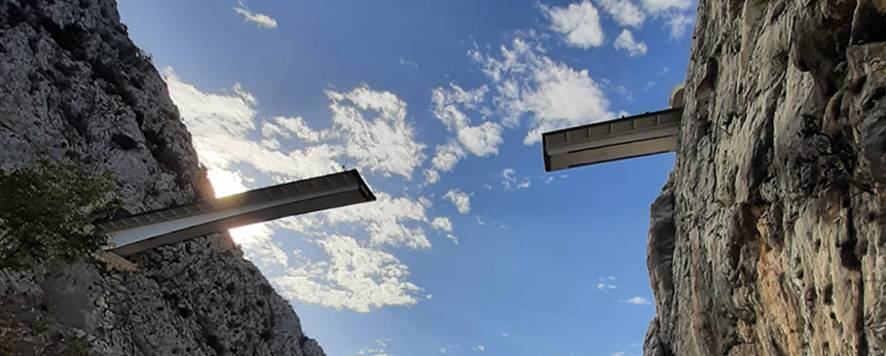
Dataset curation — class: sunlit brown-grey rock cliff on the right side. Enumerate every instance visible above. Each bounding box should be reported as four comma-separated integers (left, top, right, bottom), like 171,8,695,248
645,0,886,355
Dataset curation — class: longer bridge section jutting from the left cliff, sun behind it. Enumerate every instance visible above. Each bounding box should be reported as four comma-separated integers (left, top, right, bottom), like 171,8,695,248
97,170,375,256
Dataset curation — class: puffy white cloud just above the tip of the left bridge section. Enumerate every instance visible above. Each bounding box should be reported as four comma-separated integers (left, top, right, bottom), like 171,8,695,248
326,84,425,180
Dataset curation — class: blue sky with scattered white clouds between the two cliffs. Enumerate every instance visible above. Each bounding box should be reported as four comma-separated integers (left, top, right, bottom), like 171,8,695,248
119,0,695,356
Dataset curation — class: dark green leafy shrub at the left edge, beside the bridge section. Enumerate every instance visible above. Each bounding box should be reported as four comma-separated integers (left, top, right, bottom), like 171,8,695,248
0,162,119,270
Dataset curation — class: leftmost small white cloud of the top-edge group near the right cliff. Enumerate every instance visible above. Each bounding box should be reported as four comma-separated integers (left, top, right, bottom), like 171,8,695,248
542,0,604,48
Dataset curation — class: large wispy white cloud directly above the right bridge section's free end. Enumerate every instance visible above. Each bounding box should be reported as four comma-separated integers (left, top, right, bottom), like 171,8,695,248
470,37,613,145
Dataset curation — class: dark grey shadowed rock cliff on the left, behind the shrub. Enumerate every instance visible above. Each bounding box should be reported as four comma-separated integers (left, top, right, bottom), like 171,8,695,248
0,0,323,355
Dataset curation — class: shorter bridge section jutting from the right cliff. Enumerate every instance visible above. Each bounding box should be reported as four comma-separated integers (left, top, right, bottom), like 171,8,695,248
542,107,683,172
